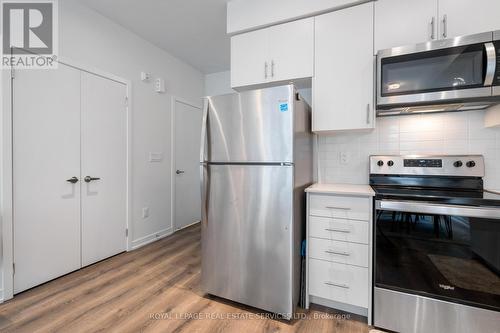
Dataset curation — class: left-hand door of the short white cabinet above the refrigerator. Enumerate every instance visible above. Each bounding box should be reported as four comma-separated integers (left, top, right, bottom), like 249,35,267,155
231,29,271,87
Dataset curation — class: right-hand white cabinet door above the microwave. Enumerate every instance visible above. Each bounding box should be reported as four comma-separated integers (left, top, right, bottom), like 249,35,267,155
439,0,500,38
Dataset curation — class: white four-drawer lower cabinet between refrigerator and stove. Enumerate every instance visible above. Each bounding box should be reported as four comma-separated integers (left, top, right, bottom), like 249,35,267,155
306,185,373,324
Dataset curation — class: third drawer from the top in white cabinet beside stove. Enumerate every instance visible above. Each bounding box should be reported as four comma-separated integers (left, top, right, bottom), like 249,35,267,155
308,238,368,267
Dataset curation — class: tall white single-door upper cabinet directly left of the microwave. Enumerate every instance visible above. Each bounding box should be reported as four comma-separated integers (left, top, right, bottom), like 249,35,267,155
313,2,374,132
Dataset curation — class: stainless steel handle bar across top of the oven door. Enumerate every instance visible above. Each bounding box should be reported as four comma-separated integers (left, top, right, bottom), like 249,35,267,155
375,200,500,219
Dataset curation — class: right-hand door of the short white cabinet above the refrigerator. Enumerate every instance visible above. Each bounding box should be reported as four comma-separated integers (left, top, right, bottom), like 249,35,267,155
269,18,314,81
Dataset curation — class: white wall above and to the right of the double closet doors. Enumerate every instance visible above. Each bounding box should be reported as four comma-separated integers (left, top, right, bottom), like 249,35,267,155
59,0,204,244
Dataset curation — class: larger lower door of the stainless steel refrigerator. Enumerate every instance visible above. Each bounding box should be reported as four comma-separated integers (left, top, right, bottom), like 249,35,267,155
201,164,293,317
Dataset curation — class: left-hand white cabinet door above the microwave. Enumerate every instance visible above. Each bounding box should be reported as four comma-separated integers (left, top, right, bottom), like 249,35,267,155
375,0,438,53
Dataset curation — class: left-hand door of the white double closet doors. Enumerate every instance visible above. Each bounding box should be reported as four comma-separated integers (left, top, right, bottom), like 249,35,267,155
13,64,81,293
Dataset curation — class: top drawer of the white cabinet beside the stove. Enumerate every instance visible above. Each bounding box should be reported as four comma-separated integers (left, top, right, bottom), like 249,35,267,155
309,194,372,221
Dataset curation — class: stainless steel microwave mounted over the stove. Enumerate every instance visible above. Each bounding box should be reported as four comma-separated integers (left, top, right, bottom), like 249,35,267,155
376,31,500,115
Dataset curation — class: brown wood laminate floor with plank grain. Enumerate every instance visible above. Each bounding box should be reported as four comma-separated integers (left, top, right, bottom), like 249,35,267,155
0,225,369,333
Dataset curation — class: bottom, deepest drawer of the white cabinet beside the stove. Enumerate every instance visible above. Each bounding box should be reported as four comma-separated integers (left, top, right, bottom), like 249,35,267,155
308,259,368,308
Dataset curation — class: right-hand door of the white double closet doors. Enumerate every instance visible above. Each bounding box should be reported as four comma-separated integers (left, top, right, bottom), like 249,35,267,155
81,73,127,266
